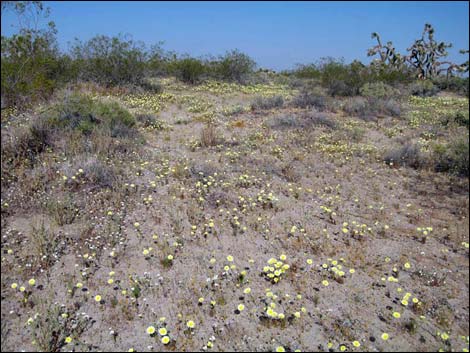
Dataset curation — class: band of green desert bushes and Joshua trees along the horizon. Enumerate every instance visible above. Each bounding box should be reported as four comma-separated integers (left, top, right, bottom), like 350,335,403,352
1,1,468,107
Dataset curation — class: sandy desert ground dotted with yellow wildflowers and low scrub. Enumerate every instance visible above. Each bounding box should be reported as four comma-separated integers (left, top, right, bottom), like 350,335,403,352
0,1,469,351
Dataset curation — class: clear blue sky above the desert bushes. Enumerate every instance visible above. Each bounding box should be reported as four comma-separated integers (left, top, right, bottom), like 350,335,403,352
2,1,469,70
